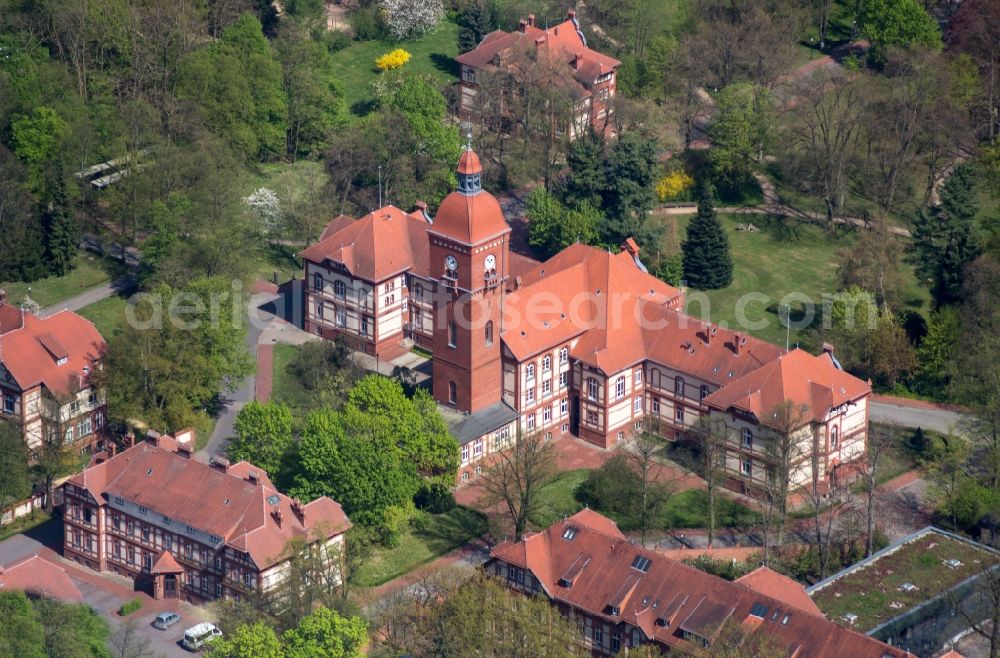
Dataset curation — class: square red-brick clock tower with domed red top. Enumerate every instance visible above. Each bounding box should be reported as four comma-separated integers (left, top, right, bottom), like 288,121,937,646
428,145,510,413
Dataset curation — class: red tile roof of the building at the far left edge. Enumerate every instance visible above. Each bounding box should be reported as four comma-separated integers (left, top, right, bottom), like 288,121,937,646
0,307,107,398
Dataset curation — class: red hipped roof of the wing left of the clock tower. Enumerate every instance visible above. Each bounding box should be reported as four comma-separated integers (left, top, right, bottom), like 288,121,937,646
301,205,430,282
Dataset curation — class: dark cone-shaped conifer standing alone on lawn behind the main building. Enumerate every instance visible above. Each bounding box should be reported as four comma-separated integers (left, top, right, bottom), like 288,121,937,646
681,183,733,290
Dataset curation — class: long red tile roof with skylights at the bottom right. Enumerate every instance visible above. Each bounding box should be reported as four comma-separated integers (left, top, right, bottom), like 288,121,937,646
490,512,909,658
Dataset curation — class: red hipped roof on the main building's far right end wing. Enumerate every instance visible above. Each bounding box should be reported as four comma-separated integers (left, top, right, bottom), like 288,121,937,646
705,348,871,425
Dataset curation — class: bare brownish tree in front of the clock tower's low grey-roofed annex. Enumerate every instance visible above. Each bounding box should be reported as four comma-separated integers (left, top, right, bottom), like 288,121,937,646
479,432,557,537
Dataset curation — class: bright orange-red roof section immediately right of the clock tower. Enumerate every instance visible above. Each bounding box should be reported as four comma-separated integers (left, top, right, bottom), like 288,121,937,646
502,243,684,373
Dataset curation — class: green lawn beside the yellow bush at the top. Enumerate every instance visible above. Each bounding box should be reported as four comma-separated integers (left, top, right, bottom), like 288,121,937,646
333,21,458,116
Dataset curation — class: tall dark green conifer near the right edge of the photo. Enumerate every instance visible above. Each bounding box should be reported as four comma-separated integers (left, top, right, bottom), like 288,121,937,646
912,164,980,307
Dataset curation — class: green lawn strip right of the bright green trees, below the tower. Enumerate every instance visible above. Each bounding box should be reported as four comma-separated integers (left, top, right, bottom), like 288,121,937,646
351,507,486,587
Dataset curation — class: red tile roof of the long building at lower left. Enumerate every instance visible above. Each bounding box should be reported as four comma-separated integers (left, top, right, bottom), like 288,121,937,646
69,436,351,569
